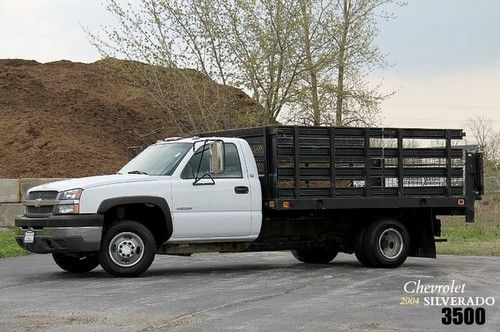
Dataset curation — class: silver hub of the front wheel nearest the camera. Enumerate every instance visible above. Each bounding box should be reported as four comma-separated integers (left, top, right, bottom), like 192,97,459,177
108,232,144,267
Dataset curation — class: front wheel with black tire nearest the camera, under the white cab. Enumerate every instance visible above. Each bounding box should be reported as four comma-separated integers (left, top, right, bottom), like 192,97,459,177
99,220,156,277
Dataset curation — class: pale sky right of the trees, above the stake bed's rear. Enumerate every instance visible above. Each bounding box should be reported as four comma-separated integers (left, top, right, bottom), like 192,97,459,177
374,0,500,130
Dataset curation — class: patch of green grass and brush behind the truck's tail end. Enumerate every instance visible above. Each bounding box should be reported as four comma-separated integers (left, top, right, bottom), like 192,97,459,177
436,197,500,256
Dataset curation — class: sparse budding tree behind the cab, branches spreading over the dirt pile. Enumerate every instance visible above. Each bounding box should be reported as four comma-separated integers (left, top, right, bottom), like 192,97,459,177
89,0,302,127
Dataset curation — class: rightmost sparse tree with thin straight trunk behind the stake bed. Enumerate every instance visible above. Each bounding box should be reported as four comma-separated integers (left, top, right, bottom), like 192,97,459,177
331,0,403,126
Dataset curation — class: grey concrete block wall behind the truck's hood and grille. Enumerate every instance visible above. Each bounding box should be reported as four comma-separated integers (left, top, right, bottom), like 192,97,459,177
0,178,64,227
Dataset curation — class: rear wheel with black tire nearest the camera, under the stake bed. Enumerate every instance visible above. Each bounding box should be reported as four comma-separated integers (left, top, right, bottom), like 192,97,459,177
355,219,410,268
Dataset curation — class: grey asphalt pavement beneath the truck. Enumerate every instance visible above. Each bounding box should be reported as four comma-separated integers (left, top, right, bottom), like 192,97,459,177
0,252,500,331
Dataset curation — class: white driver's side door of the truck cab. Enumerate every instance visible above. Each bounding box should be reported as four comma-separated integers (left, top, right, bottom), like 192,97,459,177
171,143,252,241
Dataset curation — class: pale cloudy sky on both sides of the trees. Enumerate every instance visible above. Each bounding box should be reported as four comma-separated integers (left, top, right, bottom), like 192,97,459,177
0,0,500,130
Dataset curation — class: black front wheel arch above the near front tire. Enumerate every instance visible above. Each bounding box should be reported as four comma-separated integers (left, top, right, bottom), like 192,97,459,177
103,203,169,246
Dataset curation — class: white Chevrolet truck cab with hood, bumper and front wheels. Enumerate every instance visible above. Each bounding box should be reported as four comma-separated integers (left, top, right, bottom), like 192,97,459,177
16,137,262,275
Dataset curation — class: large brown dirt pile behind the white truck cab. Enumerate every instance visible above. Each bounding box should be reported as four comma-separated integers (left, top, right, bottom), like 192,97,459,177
0,59,258,178
